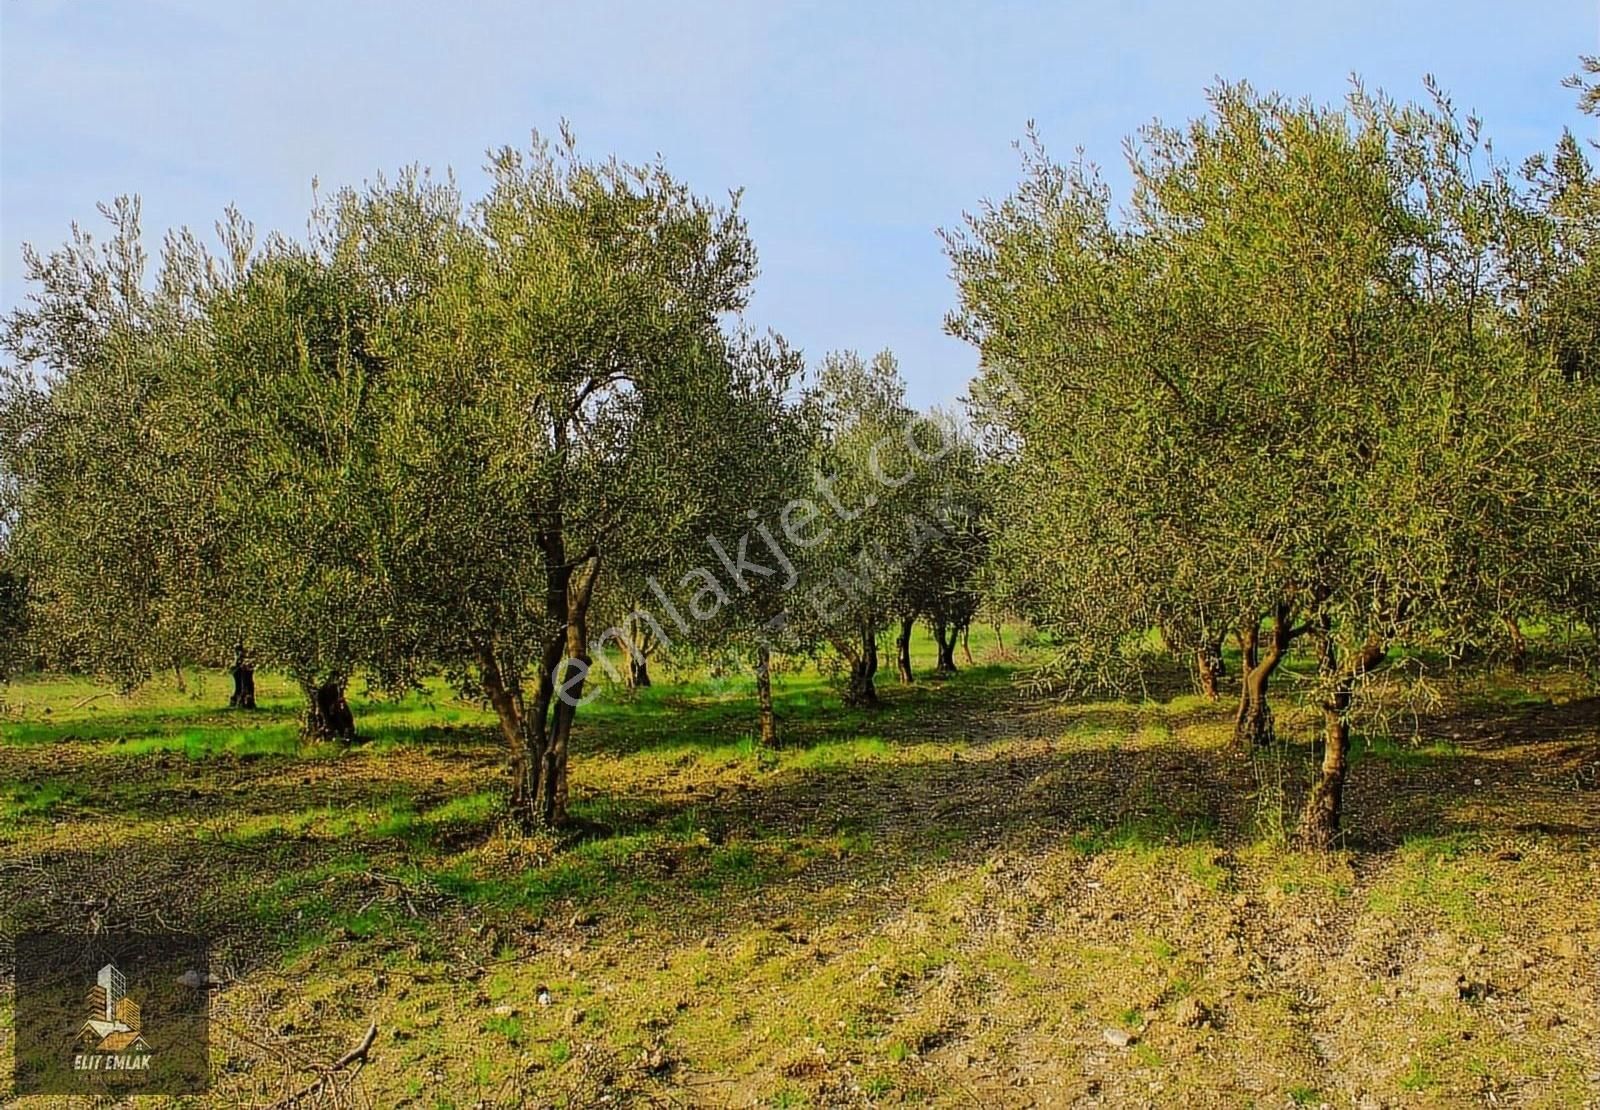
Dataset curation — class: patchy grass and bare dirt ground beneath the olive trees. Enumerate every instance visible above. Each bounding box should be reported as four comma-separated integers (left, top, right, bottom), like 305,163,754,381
0,665,1600,1107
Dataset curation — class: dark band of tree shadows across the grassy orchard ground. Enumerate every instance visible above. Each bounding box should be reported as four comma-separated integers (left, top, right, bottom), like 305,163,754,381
0,677,1600,978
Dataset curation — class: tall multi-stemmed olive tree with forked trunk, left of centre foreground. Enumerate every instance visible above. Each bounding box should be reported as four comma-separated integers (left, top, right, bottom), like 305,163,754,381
365,136,781,825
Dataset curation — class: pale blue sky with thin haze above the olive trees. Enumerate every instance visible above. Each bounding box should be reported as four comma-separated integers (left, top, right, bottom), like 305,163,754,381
0,0,1600,405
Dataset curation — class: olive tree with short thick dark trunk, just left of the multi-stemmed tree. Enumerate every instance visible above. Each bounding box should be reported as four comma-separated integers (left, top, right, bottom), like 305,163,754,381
194,240,406,741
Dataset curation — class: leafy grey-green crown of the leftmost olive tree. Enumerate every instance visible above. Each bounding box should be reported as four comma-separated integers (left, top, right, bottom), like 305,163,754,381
0,198,219,686
